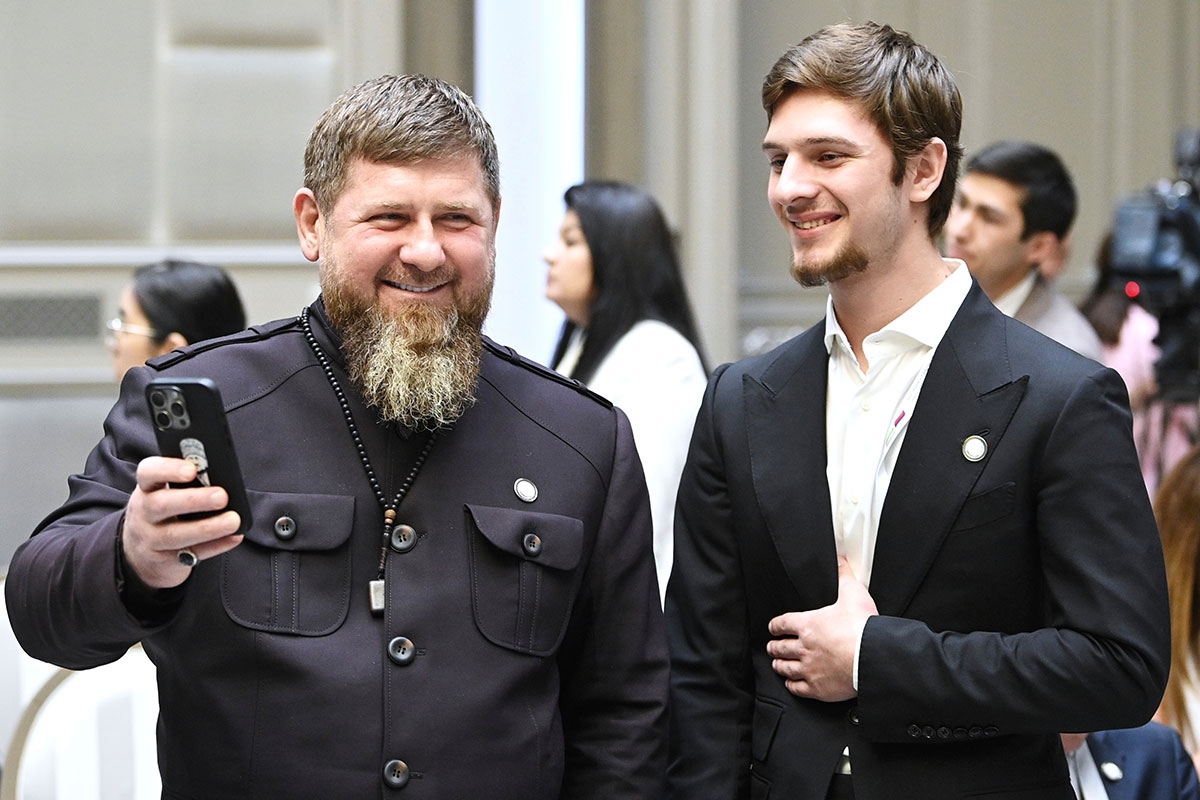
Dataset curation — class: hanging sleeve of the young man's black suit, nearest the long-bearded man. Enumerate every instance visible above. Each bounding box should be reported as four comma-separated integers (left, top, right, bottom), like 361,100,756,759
666,367,754,800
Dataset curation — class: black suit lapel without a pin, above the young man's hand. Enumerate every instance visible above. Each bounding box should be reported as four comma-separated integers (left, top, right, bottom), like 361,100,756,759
743,324,838,608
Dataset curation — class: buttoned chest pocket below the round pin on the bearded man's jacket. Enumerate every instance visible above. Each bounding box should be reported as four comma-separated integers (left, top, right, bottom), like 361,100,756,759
467,504,583,656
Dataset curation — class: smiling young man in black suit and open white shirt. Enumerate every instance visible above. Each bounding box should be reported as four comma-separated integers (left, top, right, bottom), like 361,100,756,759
666,18,1170,800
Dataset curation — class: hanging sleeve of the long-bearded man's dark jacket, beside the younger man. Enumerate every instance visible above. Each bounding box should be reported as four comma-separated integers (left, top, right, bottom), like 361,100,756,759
559,409,670,800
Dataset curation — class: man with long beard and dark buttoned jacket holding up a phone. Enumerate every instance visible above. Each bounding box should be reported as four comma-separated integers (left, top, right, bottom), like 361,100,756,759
7,76,668,800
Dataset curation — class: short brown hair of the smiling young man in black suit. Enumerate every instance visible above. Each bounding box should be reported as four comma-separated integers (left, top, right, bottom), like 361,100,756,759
762,23,962,237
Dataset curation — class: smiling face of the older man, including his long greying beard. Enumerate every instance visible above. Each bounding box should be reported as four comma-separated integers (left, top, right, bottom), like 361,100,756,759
309,158,498,429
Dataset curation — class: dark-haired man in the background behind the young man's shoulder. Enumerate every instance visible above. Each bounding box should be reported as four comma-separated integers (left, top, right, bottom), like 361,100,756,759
946,140,1104,361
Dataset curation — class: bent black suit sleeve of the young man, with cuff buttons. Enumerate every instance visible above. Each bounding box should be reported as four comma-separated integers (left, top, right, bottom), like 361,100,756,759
858,369,1170,742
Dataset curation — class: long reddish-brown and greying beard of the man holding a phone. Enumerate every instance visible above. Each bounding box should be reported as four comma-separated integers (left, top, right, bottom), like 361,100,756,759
322,269,491,431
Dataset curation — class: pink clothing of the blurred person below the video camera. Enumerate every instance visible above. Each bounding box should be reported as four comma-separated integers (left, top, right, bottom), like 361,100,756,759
1104,305,1200,497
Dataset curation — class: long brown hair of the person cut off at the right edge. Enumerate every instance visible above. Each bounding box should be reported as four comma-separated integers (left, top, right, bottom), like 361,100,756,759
1154,445,1200,750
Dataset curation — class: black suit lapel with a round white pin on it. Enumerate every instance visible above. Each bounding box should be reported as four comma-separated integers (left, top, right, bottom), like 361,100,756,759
870,283,1027,615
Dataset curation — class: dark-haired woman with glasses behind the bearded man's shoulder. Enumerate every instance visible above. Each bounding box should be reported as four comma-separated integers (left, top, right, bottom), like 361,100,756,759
108,260,246,380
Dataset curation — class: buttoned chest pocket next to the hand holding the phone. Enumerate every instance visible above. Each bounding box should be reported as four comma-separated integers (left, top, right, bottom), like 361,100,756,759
221,492,354,636
